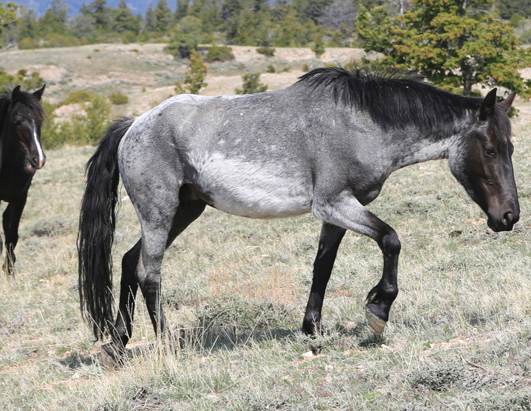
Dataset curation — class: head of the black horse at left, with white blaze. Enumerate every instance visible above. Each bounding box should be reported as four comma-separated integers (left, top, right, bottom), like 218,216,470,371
9,86,46,174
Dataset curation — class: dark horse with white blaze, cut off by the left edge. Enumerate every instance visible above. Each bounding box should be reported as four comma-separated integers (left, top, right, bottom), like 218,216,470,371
0,86,46,275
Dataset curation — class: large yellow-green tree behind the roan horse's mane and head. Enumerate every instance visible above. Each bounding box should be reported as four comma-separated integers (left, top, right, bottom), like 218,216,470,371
356,0,525,95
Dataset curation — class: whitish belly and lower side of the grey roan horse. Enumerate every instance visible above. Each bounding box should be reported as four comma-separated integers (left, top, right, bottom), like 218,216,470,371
190,154,311,218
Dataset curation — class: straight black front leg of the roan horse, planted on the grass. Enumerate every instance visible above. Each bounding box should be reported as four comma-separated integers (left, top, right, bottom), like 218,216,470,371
302,223,346,335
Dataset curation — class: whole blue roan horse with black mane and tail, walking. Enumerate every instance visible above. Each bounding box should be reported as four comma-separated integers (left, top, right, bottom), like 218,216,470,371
78,68,520,354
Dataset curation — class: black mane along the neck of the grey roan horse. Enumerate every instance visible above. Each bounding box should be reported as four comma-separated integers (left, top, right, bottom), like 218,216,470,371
299,67,481,129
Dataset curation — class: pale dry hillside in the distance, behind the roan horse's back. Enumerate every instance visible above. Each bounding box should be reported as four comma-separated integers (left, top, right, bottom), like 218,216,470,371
0,44,370,116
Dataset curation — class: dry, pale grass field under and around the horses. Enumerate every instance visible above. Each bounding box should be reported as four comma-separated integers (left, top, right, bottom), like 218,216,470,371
0,43,531,410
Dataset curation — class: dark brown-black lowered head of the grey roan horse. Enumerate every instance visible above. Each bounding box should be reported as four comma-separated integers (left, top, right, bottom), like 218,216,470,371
449,89,520,231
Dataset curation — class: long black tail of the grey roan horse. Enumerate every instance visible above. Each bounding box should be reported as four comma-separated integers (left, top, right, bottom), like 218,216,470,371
77,119,133,339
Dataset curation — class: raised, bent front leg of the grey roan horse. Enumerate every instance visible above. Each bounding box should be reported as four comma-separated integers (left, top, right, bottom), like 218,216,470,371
313,191,400,335
